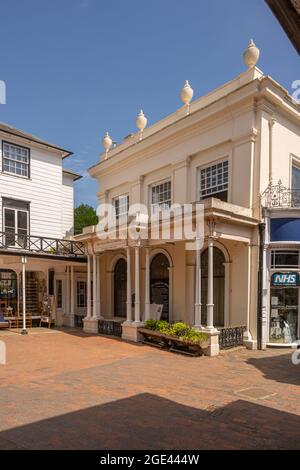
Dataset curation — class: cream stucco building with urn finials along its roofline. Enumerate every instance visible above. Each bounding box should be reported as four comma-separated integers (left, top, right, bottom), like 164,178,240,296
77,44,300,354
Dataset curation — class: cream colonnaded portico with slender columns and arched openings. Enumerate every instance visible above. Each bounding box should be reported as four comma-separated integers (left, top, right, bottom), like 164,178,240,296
79,199,258,355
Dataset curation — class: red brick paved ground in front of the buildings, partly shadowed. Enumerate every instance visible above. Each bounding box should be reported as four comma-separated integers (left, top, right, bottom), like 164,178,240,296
0,330,300,449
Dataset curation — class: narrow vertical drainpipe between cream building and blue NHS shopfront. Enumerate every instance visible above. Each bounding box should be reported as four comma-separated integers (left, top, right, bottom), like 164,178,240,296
257,223,266,350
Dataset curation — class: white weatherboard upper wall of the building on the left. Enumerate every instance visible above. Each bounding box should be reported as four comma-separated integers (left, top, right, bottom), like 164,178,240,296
0,134,73,238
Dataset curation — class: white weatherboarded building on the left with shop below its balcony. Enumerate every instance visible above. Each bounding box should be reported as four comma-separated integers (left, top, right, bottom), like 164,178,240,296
0,123,86,327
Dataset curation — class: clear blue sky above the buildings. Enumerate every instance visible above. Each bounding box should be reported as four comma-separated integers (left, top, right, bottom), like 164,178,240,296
0,0,300,205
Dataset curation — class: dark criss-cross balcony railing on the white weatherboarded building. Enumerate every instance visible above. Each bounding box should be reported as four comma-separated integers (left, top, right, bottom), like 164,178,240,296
0,231,85,258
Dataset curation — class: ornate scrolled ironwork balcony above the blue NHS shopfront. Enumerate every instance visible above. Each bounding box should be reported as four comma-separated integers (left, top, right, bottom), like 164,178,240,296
261,181,300,209
